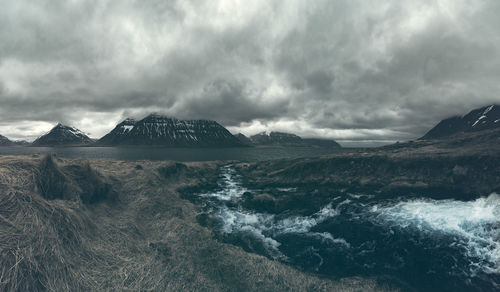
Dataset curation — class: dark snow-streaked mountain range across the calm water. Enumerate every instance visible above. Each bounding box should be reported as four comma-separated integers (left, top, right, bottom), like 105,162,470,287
16,114,340,147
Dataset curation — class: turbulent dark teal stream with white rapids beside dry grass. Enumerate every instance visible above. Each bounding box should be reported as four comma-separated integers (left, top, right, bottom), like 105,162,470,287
190,165,500,291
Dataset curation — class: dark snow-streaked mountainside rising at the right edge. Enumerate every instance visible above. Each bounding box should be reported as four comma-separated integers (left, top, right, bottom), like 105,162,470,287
420,105,500,140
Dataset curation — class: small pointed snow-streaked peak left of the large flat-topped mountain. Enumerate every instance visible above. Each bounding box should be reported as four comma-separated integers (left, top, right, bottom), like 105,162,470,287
32,123,93,146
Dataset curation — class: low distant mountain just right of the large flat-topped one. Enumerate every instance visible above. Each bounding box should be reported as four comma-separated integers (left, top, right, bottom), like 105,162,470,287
246,132,341,148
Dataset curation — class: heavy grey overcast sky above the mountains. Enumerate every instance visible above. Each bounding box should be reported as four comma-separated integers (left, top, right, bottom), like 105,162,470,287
0,0,500,142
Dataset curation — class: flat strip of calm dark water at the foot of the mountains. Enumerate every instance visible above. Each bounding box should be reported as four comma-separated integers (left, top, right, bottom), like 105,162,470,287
0,147,348,162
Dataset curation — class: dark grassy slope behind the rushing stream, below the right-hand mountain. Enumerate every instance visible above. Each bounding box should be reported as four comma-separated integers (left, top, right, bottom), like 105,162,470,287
236,134,500,200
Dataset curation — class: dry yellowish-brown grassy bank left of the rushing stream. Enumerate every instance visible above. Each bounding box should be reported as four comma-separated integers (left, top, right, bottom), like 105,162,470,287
0,157,386,291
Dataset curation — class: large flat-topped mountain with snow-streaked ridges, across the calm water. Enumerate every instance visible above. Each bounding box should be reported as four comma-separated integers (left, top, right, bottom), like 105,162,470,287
97,114,243,147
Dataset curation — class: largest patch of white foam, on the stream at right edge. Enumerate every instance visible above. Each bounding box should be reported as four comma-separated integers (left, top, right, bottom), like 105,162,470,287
371,194,500,273
